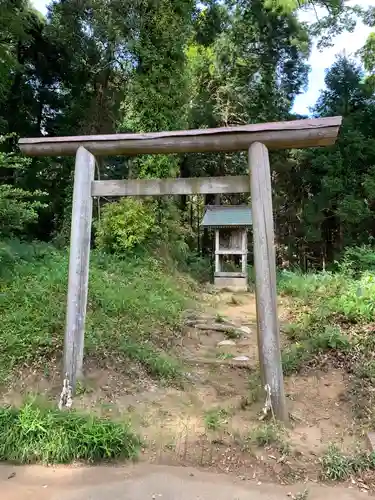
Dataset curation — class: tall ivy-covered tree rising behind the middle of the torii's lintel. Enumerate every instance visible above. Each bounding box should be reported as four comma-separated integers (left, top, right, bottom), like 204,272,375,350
121,0,195,177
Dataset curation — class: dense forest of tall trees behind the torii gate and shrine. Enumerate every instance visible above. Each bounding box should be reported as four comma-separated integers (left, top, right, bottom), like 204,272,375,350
0,0,375,269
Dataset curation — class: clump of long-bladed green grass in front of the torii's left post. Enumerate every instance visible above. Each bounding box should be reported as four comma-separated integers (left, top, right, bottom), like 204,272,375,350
0,401,141,464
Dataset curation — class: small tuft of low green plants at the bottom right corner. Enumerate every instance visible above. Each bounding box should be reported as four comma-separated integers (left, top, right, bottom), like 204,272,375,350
321,445,375,481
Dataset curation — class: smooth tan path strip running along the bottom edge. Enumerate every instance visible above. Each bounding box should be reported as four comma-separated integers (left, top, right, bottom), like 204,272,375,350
0,465,368,500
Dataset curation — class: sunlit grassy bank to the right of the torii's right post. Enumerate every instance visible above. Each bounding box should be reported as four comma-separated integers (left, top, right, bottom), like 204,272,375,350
278,247,375,426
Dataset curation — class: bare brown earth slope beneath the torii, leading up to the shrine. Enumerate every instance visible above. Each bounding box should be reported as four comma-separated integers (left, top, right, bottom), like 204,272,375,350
2,293,373,498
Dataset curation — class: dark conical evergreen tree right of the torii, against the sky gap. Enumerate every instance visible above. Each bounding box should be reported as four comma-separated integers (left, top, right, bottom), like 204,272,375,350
277,56,375,267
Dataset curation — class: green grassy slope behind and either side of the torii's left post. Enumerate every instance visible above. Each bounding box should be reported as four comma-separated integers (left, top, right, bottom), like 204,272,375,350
0,242,193,380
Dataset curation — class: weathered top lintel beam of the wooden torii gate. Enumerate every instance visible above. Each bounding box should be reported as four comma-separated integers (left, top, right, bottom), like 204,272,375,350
19,116,342,156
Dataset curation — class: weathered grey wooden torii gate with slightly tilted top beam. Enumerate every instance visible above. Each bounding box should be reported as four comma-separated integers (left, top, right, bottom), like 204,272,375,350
19,116,342,421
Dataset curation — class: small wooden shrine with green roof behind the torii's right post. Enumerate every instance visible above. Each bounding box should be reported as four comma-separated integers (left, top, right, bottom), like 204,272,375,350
201,205,252,291
